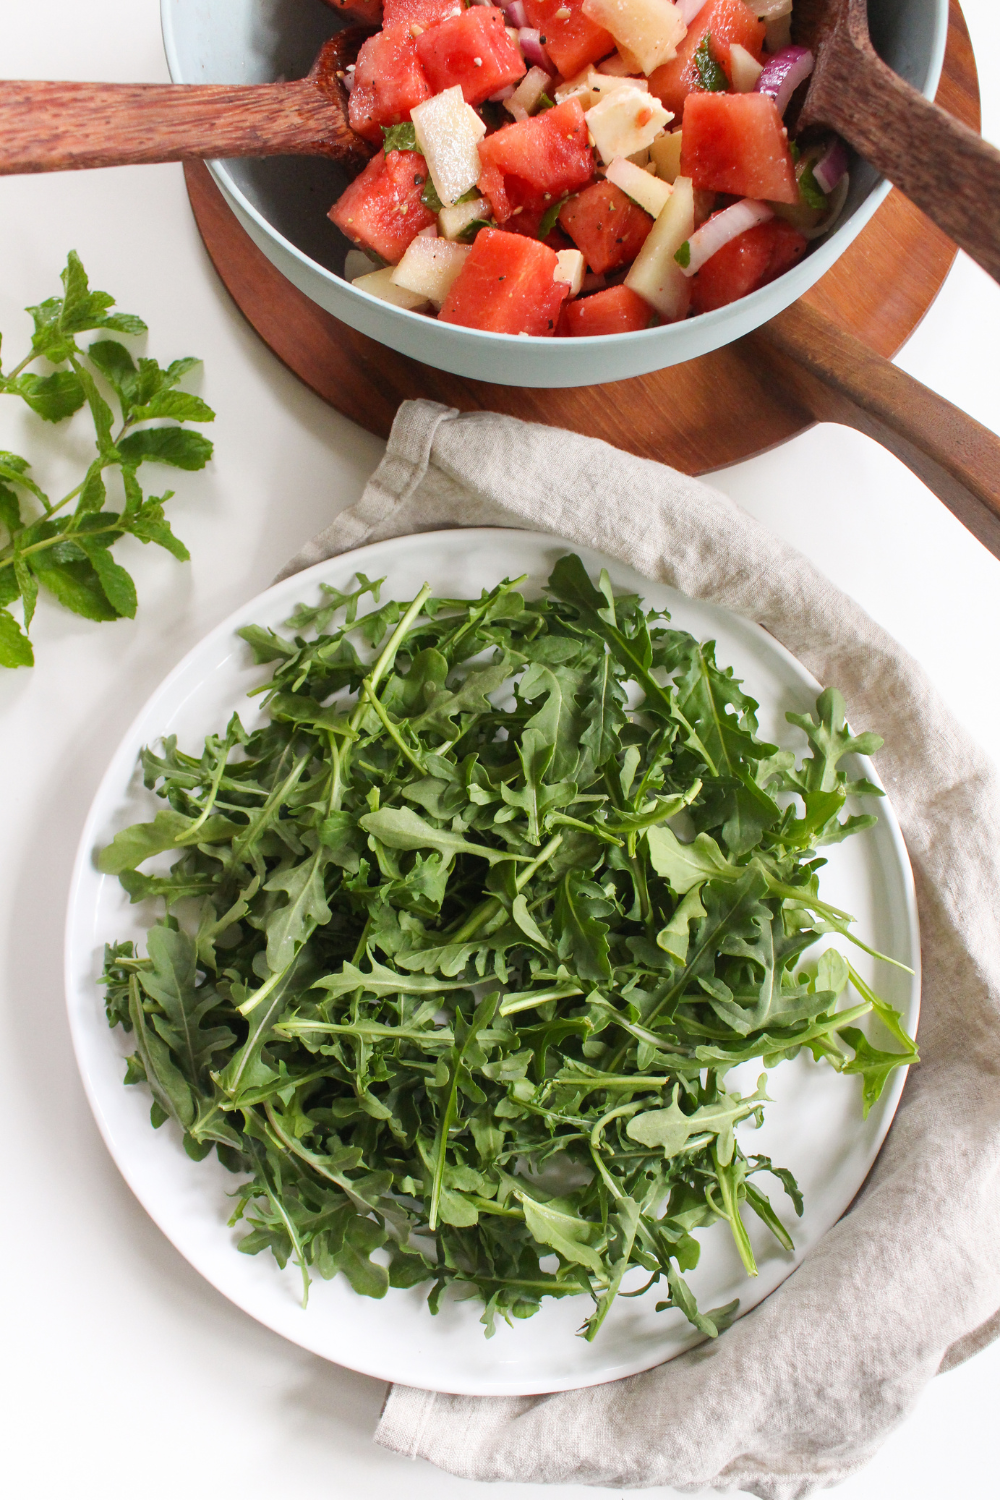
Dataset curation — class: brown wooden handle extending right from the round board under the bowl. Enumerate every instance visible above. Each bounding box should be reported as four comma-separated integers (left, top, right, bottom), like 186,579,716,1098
750,302,1000,558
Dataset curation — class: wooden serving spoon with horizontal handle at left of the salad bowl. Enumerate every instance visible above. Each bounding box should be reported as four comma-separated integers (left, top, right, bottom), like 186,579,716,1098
0,27,376,176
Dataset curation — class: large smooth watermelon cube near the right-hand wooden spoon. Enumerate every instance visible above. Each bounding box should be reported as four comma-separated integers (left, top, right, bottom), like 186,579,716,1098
681,90,799,203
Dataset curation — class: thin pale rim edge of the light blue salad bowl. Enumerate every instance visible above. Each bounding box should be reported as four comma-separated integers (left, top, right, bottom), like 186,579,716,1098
160,0,949,350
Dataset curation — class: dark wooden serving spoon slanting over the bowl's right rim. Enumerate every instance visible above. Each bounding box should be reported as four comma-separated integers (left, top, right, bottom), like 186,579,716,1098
795,0,1000,281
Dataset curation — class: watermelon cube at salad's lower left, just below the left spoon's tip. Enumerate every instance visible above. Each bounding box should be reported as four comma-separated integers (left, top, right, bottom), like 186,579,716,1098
330,152,435,266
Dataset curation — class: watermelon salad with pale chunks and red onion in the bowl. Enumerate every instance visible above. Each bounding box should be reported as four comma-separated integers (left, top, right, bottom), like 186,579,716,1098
330,0,847,338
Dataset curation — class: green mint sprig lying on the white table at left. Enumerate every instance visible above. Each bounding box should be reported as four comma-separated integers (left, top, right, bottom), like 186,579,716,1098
0,251,214,668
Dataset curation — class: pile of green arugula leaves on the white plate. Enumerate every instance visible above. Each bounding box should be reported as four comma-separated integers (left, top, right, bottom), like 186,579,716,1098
100,557,918,1338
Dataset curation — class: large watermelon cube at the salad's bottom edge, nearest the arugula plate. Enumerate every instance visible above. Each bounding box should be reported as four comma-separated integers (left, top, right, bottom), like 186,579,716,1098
438,230,570,338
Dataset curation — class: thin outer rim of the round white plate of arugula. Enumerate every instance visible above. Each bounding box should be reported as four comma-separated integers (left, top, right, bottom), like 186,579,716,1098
63,527,922,1395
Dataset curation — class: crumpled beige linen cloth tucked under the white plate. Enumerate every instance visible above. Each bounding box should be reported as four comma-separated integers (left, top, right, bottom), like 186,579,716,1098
286,402,1000,1500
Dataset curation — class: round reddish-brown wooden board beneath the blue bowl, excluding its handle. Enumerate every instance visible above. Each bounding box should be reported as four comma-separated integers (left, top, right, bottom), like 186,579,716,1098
184,0,979,474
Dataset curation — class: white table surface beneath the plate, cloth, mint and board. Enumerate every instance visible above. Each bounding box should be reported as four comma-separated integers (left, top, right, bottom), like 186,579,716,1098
0,0,1000,1500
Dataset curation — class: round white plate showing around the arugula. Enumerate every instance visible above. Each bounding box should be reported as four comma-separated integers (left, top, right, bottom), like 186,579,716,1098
66,530,919,1395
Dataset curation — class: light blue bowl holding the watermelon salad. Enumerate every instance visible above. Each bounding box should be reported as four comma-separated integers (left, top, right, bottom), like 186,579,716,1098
160,0,948,386
